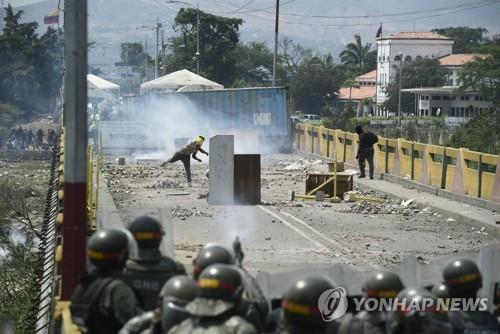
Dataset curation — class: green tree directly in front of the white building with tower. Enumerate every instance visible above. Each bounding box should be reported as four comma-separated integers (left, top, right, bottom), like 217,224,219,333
384,58,449,114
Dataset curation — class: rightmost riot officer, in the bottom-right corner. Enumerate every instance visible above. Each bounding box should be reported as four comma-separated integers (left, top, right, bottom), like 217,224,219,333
443,259,500,334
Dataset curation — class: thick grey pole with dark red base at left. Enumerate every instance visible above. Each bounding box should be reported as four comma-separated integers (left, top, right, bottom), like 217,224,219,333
61,0,87,300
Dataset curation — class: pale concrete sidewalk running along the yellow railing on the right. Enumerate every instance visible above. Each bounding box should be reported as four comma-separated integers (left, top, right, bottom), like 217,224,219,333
354,176,500,237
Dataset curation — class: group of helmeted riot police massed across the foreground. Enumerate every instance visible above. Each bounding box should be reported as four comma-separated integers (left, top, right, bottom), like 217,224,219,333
70,216,500,334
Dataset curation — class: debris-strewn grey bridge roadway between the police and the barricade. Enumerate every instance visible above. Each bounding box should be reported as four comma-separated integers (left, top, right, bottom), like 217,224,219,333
104,155,499,292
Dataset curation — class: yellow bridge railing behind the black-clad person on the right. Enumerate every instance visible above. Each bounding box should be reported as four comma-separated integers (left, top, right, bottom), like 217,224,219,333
294,124,500,203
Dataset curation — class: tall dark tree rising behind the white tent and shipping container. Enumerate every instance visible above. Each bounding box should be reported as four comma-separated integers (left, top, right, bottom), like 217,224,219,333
164,8,243,85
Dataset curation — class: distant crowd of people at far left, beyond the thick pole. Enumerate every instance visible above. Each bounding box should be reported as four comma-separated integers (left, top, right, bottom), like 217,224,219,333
0,127,56,151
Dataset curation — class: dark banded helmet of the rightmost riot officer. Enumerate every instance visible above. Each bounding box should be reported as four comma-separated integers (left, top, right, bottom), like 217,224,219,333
443,259,483,297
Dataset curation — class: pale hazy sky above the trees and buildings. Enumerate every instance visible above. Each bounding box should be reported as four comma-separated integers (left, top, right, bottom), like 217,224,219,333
0,0,500,61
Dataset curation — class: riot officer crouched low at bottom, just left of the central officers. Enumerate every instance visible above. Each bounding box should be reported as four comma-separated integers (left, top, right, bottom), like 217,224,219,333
119,275,197,334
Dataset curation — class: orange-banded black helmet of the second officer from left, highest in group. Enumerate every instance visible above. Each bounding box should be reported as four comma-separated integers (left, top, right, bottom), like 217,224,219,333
128,216,165,249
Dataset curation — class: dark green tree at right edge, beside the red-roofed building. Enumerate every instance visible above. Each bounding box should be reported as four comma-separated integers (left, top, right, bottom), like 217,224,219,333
460,43,500,107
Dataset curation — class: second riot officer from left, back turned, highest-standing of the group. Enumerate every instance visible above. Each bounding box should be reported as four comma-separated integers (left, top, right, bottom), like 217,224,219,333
123,216,186,311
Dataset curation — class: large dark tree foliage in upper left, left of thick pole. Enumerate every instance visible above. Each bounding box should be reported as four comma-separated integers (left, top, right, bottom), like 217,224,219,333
0,5,62,117
